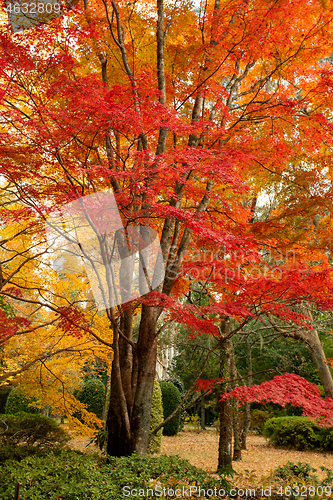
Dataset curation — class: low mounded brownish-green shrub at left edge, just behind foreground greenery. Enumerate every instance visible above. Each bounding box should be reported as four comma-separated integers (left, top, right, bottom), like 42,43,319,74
0,413,70,447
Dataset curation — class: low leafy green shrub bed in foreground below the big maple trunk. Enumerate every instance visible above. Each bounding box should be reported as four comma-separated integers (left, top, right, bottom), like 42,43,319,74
0,450,231,500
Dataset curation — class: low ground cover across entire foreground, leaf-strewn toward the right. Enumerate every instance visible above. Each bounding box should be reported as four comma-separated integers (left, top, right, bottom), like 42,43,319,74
0,431,333,500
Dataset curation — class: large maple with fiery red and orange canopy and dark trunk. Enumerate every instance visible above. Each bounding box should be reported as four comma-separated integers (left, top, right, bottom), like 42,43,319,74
0,0,333,455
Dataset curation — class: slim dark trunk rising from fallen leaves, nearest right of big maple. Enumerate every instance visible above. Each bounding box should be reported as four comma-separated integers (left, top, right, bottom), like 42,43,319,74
218,318,232,470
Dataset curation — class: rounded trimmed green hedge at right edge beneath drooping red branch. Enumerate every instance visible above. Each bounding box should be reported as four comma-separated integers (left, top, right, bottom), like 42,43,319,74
263,416,333,451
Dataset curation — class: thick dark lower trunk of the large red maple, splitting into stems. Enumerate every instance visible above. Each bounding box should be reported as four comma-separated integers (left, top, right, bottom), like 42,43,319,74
107,306,157,456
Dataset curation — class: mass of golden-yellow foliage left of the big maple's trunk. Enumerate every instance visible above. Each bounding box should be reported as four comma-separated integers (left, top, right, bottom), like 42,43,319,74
0,184,112,436
